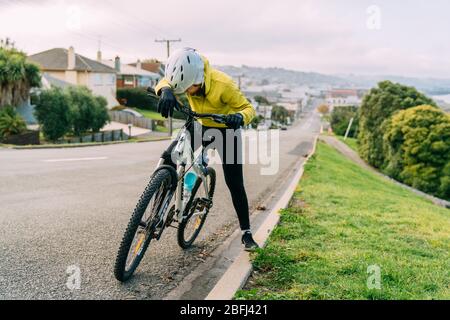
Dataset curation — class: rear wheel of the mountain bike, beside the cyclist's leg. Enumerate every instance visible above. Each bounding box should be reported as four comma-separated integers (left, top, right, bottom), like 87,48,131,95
177,168,216,249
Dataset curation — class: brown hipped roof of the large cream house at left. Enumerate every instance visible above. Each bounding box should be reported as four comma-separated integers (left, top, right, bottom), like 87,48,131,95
28,48,116,73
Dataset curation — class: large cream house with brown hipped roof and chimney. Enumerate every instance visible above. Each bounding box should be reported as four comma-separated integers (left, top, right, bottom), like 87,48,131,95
28,47,119,108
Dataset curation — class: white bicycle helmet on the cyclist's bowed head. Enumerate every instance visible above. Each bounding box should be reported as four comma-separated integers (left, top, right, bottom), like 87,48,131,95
165,48,205,94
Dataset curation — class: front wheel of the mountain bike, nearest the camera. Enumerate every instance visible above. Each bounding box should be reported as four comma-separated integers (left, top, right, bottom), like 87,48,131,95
114,169,172,282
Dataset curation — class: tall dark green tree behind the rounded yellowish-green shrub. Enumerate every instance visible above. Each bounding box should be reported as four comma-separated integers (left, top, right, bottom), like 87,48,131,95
358,81,436,168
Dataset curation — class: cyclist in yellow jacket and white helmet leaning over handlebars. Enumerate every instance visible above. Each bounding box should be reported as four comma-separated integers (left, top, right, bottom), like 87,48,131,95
155,48,258,251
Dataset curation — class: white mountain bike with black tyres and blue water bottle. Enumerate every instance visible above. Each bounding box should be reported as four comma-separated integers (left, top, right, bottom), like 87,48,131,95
114,101,226,282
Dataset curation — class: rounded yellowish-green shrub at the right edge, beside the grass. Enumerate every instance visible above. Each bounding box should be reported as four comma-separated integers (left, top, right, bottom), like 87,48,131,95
382,105,450,199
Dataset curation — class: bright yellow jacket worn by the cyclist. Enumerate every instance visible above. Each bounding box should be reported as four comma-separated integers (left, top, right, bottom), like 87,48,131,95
155,57,256,128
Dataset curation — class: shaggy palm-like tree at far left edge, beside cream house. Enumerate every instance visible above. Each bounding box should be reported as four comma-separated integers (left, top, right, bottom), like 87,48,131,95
0,46,41,108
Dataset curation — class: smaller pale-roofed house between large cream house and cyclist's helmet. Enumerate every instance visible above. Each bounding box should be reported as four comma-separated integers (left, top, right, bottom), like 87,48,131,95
97,52,161,88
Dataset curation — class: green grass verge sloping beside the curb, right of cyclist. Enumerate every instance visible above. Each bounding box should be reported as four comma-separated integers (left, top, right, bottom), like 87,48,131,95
235,143,450,300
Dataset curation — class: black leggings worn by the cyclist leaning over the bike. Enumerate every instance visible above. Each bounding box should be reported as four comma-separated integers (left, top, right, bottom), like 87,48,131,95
189,123,250,230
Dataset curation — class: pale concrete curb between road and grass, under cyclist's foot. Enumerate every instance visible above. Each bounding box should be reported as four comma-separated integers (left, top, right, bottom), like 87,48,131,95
205,132,319,300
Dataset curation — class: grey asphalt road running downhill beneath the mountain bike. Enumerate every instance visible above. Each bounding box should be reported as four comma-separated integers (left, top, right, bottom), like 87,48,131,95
0,109,320,299
